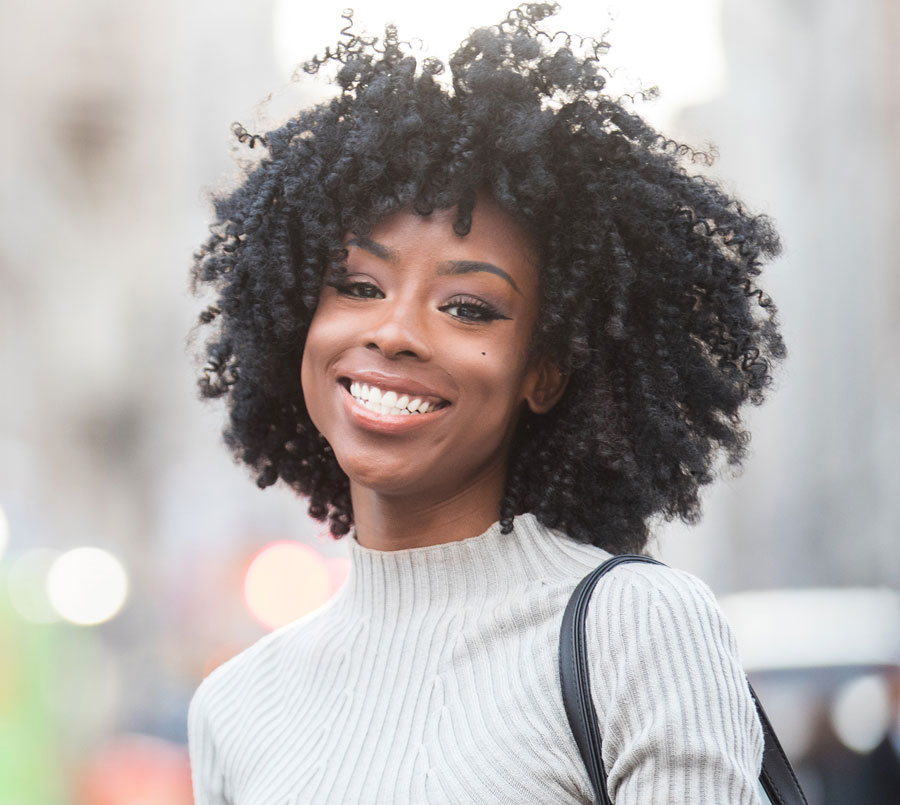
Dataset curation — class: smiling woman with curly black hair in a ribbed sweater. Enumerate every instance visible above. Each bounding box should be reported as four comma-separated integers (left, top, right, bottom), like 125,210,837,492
190,4,784,805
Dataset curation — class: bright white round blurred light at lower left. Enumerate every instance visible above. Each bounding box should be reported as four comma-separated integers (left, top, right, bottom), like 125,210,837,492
47,547,128,626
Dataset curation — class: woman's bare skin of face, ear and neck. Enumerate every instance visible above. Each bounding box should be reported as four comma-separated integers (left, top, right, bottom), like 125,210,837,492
301,196,565,550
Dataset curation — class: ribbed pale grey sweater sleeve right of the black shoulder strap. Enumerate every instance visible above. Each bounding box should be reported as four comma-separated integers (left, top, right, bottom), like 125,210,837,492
587,565,763,805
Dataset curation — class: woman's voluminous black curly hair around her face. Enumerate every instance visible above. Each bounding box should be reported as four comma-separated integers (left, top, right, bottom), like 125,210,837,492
193,3,785,553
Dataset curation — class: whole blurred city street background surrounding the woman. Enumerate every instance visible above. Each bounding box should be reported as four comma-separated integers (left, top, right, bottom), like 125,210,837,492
0,0,900,805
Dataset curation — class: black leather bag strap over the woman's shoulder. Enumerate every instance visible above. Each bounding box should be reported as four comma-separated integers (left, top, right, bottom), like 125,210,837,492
559,554,807,805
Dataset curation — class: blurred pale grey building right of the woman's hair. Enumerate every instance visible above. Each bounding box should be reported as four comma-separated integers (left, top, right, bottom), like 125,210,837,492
652,0,900,588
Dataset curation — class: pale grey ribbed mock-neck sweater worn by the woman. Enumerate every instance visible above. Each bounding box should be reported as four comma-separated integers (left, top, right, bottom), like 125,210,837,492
189,515,762,805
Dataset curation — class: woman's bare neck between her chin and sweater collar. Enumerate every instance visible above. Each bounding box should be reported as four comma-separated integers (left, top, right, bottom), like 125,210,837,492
350,464,505,551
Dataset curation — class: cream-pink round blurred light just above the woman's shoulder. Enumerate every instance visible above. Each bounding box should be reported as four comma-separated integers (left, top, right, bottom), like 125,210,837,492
244,542,332,629
